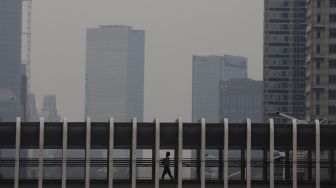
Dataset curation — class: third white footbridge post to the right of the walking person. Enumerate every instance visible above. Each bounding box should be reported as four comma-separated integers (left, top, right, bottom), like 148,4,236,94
223,118,229,188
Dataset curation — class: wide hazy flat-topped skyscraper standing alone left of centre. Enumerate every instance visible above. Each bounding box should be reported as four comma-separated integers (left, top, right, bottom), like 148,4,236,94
85,25,145,121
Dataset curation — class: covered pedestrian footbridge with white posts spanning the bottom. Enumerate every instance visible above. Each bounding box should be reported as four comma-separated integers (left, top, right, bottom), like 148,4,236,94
0,118,330,188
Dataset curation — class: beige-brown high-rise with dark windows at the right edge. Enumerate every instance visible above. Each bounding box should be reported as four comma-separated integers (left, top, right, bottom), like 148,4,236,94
306,0,336,123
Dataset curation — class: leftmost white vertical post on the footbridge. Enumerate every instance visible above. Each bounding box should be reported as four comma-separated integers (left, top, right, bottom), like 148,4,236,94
14,117,21,188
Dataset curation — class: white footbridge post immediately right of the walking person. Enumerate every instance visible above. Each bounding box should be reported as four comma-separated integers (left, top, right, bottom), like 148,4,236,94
177,118,183,188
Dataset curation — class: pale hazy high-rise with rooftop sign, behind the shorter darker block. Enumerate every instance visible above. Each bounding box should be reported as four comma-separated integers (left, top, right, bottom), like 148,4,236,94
192,55,247,122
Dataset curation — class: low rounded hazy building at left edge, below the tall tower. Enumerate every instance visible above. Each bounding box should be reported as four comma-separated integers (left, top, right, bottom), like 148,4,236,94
0,88,20,122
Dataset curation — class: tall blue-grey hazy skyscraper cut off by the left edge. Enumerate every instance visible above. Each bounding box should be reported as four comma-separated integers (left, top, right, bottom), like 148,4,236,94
0,0,24,121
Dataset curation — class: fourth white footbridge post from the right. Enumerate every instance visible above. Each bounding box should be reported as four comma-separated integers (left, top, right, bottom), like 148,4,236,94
246,119,251,188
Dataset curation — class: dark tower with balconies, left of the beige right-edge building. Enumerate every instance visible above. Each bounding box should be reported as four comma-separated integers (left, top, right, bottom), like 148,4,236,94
263,0,306,123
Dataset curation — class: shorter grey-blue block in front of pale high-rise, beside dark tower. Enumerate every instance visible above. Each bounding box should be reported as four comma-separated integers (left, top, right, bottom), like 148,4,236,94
219,79,264,123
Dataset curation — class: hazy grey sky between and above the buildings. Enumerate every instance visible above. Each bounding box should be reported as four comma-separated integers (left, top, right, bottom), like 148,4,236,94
31,0,263,121
